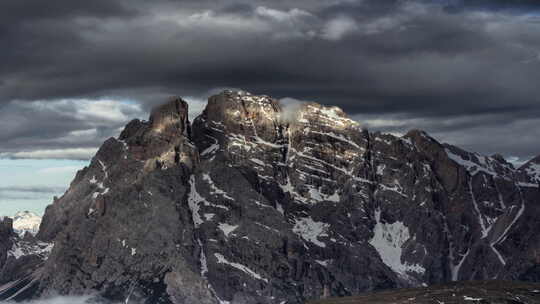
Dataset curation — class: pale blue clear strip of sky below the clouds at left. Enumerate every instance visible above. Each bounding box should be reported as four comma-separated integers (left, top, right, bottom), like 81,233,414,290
0,159,88,216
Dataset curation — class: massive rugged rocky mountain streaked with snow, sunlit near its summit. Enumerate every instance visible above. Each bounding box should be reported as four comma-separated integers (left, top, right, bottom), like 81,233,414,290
0,91,540,304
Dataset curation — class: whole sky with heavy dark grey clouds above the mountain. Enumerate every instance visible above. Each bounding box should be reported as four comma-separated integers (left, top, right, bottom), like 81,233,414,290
0,0,540,214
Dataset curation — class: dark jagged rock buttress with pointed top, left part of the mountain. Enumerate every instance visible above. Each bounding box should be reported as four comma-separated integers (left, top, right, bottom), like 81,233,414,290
33,98,206,303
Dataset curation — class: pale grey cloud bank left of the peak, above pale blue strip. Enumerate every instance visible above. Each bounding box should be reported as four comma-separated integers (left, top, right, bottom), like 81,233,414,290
0,99,143,159
